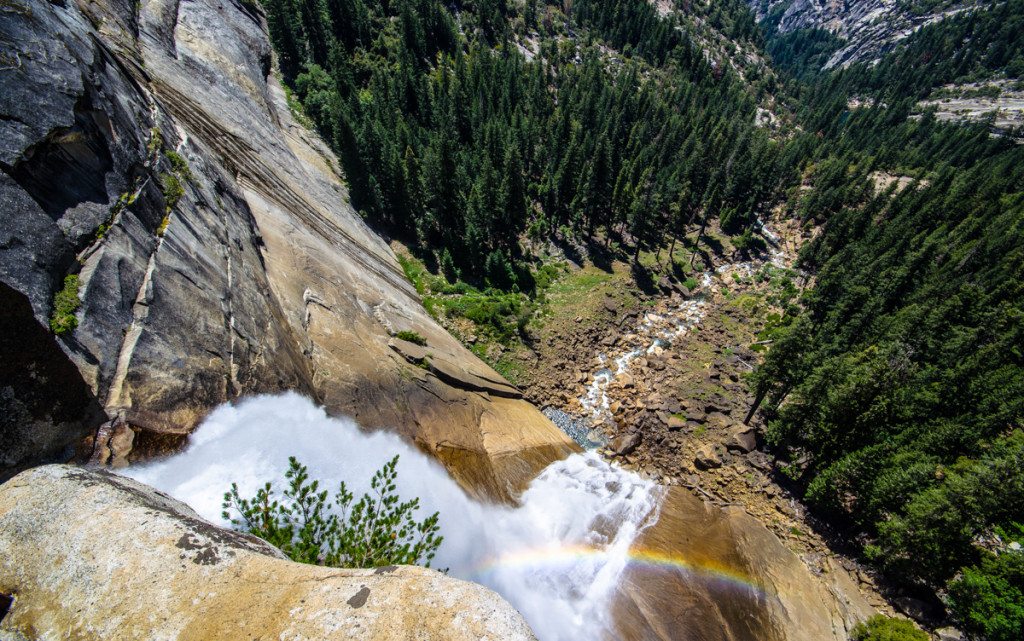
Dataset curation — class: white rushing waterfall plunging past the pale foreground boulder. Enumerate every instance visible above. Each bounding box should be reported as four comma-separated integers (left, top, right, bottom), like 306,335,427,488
127,393,659,641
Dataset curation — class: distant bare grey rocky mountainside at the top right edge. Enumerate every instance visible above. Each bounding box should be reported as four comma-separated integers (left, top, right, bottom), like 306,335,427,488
748,0,979,69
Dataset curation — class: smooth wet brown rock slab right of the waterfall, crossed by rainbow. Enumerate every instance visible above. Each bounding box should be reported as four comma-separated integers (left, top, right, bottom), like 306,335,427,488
613,487,874,641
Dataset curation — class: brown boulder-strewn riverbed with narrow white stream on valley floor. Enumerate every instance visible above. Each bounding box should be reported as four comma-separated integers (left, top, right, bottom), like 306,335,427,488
519,217,894,614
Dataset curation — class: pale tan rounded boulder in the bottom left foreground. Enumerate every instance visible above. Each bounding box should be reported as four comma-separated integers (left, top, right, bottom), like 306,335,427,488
0,465,534,641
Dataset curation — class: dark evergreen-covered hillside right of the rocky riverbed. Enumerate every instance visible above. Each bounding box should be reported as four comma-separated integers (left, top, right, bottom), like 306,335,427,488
755,1,1024,639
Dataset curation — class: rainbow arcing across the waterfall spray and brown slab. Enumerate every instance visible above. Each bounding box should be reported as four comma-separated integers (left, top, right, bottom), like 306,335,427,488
471,545,765,599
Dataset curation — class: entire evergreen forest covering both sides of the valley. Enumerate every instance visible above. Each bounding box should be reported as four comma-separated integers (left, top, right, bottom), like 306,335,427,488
264,0,1024,639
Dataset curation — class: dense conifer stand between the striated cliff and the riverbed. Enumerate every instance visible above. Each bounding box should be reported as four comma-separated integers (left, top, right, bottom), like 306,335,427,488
267,0,782,290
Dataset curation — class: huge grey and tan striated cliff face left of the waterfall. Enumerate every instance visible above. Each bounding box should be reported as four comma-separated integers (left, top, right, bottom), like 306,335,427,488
0,0,575,501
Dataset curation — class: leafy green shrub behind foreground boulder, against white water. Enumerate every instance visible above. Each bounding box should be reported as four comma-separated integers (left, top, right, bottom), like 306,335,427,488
223,456,443,567
